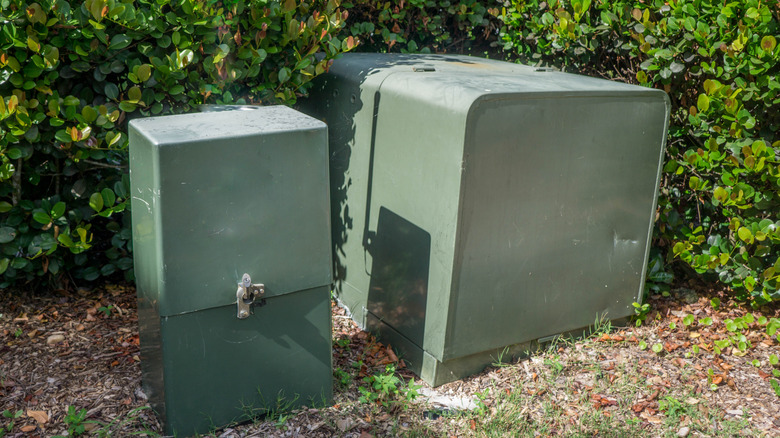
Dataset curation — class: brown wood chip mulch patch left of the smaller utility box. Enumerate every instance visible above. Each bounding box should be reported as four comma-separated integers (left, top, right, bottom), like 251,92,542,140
0,285,158,437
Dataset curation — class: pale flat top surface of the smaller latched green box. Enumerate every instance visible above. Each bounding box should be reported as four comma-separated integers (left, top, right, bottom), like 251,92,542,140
130,105,325,146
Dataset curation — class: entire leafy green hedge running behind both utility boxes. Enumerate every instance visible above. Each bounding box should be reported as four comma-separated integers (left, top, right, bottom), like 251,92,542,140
0,0,780,304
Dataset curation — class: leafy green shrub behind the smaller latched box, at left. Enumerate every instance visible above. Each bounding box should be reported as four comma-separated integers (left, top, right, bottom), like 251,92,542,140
0,0,355,288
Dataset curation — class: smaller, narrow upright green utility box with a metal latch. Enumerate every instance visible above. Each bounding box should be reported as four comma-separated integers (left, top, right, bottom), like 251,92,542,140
130,107,333,436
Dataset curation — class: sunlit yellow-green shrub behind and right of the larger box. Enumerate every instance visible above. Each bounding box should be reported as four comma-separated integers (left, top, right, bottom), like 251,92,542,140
497,0,780,304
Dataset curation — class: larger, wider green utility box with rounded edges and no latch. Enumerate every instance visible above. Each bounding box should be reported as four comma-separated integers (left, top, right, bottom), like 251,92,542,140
302,54,669,385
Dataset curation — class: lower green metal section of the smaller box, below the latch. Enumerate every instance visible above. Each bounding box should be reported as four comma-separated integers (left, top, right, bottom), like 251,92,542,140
139,286,333,436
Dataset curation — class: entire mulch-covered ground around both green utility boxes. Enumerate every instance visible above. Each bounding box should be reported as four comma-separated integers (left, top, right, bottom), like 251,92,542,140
0,285,780,438
